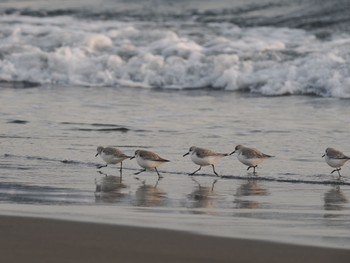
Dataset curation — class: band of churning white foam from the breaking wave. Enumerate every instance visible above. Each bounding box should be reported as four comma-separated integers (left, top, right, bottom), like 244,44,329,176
0,15,350,98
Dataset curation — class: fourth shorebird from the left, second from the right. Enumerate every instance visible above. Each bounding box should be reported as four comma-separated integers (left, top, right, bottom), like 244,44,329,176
230,144,273,174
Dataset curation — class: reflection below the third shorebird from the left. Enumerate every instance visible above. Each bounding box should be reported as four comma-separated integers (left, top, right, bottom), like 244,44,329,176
188,178,218,208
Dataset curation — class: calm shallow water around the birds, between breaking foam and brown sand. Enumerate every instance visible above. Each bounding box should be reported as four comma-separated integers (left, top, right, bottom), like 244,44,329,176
0,86,350,248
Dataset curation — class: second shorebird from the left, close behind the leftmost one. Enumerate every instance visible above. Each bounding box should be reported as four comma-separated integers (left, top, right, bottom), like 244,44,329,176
130,150,170,178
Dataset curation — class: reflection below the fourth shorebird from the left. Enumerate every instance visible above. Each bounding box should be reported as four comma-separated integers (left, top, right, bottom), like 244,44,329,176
234,180,270,209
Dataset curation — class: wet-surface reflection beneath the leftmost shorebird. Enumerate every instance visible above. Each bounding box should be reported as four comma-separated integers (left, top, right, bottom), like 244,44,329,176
95,171,127,203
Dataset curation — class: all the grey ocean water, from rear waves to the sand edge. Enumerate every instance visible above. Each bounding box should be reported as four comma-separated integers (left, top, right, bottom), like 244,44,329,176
0,0,350,249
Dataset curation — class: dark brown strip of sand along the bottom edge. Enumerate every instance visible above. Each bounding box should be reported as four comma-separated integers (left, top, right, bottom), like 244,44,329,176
0,216,350,263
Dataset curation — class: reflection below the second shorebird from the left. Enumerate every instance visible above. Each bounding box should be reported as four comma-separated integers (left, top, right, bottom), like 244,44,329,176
134,178,167,207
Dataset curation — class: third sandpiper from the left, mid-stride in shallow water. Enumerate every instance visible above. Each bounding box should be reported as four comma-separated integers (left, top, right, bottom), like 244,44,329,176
183,146,229,176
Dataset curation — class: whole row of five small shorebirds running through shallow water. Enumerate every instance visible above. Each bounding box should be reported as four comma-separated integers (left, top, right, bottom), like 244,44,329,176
95,144,350,178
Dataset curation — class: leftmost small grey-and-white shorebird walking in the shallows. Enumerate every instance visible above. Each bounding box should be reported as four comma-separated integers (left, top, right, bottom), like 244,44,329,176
95,146,130,174
